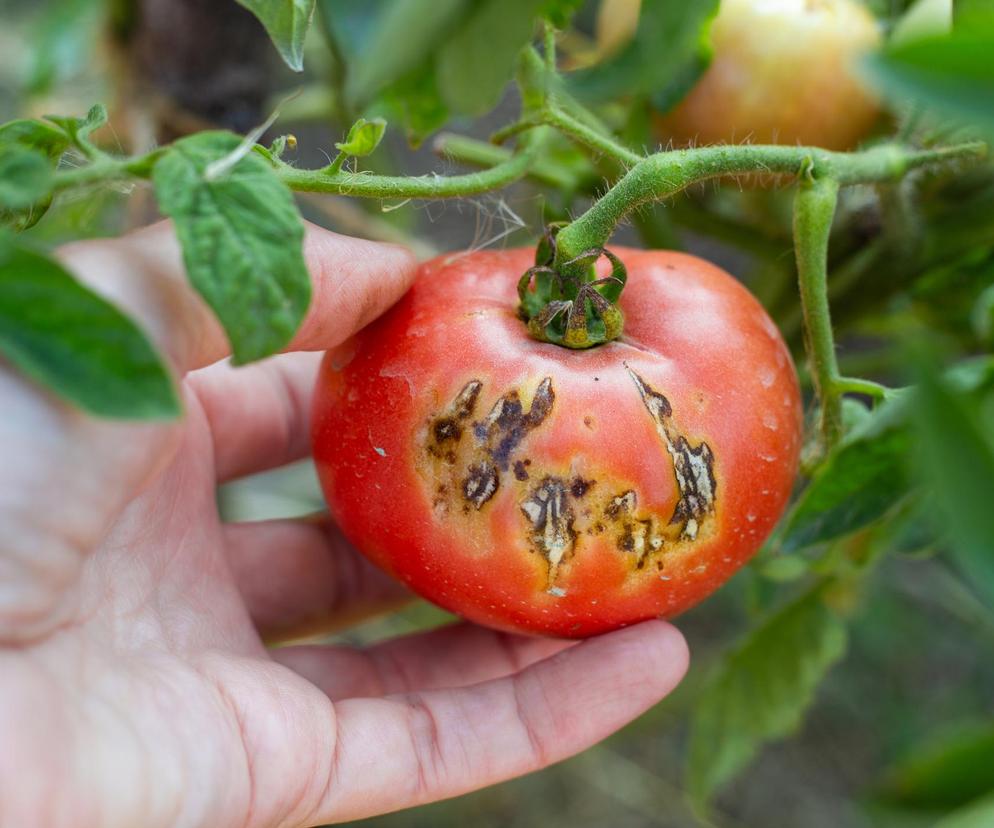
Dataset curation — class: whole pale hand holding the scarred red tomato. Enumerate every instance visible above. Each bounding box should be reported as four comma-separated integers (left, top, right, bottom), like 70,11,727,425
0,223,687,828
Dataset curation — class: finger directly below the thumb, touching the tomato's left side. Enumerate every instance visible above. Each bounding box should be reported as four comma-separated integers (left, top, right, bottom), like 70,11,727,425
187,353,322,483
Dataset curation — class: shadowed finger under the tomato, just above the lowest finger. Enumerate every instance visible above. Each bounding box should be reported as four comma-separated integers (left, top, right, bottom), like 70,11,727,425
272,623,576,701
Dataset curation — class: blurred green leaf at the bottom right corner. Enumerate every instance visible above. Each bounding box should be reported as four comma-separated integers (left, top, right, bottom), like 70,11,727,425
875,722,994,811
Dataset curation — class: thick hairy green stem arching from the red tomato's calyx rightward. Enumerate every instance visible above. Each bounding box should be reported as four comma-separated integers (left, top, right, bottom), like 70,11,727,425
557,142,986,262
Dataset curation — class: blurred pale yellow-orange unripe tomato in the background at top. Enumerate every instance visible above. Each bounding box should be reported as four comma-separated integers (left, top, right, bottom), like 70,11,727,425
659,0,880,150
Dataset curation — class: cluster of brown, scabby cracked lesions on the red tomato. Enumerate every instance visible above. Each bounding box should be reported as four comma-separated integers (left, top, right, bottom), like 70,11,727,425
423,365,717,590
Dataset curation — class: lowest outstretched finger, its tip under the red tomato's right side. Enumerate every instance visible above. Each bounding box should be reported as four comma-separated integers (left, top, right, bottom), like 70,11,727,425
308,621,688,824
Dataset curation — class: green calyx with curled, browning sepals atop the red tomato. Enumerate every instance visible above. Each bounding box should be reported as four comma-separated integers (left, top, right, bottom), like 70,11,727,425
518,224,628,350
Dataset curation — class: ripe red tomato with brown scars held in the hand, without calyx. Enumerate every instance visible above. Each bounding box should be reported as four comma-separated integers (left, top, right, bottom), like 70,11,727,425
313,249,801,637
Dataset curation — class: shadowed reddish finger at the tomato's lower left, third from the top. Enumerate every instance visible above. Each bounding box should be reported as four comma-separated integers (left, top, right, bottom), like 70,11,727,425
224,516,411,640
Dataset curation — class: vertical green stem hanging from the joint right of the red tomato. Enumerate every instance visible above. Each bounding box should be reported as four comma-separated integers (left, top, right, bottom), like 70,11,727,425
794,175,843,452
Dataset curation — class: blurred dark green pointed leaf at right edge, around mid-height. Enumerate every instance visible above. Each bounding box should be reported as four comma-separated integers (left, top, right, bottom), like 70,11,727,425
912,365,994,606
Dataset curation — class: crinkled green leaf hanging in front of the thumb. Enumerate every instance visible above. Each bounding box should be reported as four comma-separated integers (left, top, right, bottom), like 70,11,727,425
153,132,311,364
